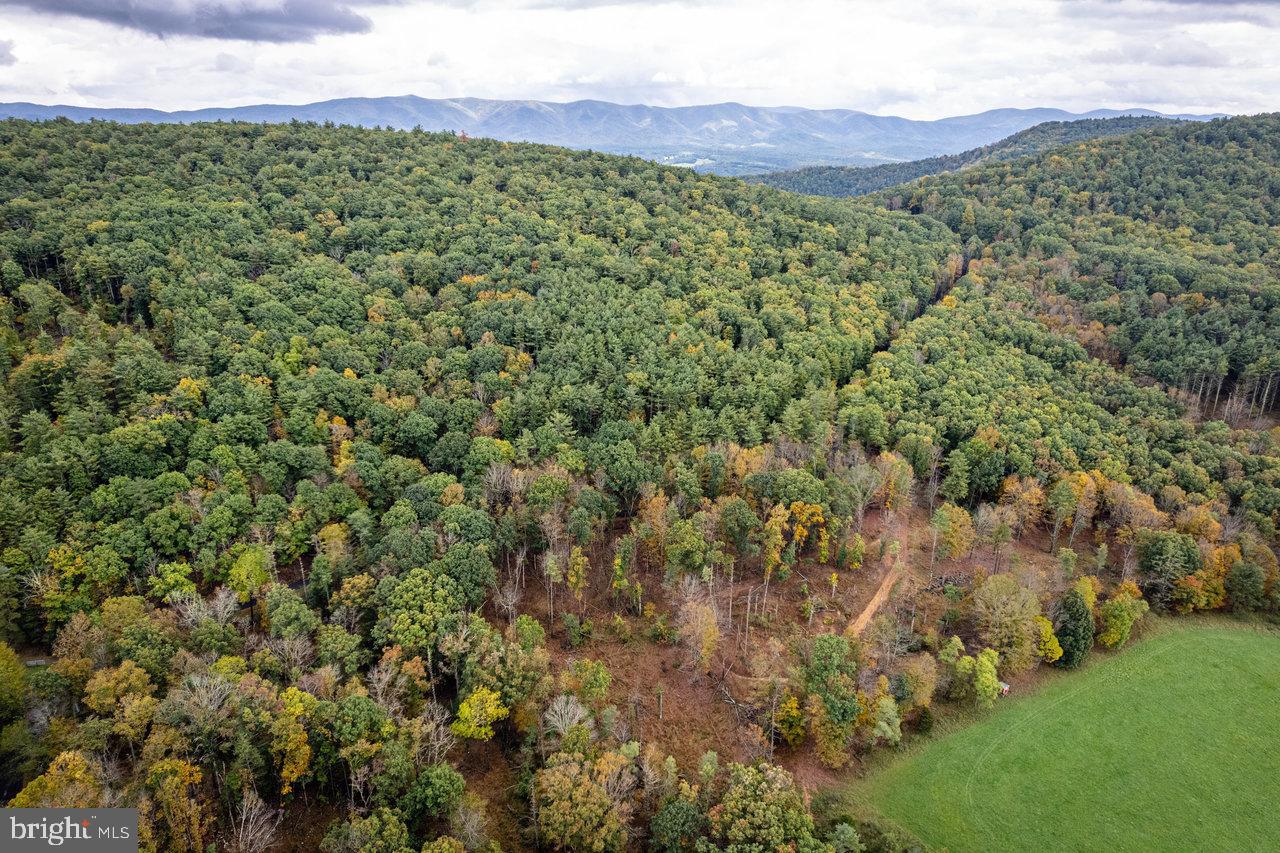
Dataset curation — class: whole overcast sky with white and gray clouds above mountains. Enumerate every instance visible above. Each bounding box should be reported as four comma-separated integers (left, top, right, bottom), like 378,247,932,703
0,0,1280,118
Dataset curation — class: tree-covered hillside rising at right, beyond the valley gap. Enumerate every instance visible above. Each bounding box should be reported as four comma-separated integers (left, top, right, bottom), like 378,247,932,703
884,115,1280,416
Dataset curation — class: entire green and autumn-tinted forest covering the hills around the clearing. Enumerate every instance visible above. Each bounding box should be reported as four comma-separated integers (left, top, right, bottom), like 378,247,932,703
0,115,1280,853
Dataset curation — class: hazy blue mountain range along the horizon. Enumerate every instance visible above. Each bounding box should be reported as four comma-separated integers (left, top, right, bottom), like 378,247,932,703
0,95,1217,174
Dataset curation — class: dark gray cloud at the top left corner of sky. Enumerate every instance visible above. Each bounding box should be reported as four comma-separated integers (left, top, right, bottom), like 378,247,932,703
0,0,397,42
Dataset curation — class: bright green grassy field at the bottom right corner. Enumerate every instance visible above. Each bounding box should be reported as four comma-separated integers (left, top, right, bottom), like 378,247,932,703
855,622,1280,853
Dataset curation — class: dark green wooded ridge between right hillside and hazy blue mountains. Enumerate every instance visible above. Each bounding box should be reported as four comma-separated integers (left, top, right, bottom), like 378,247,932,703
746,115,1176,196
